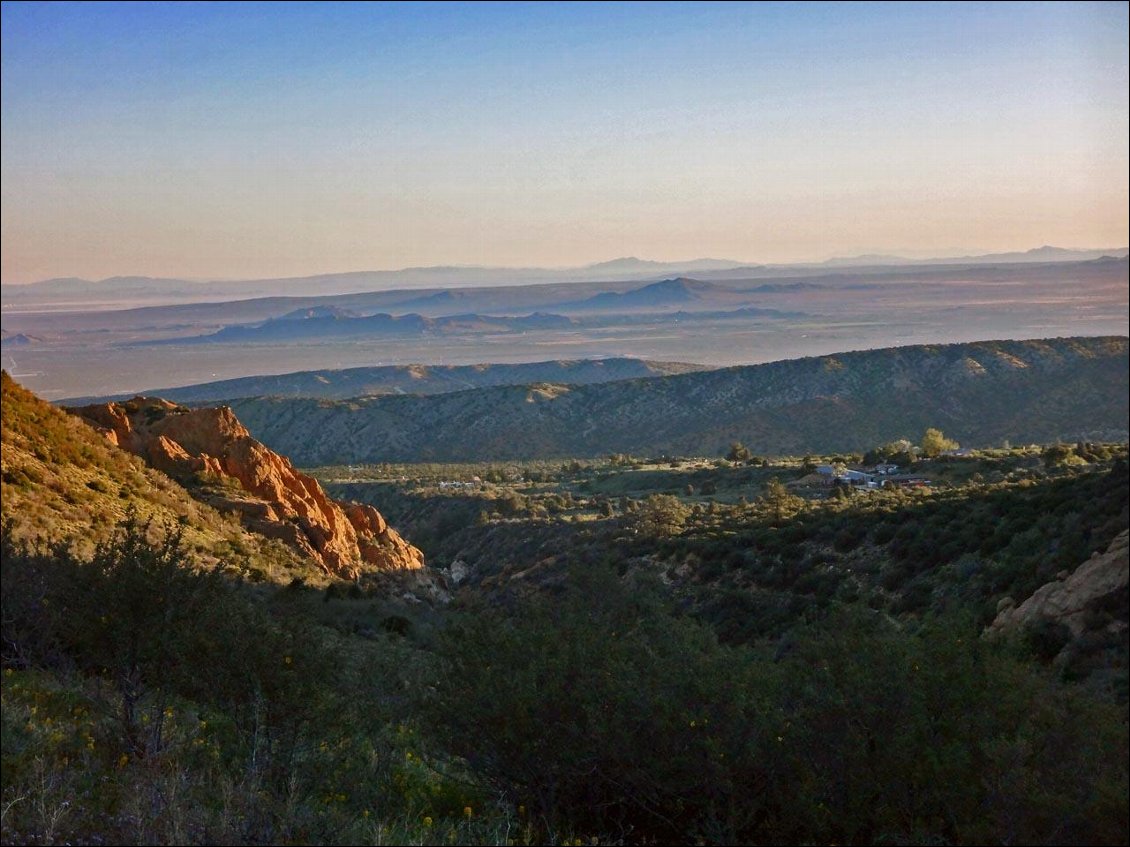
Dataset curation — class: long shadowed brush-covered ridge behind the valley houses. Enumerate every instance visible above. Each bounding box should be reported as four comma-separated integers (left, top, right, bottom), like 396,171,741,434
233,337,1130,466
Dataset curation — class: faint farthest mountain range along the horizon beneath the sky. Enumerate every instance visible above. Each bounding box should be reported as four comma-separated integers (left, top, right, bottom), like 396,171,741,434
0,246,1130,306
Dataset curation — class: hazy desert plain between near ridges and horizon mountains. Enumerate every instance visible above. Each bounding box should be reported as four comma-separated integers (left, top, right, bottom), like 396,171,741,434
2,260,1130,401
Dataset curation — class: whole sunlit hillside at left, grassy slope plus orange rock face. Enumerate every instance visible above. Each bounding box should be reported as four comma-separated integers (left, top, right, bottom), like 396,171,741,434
2,372,423,579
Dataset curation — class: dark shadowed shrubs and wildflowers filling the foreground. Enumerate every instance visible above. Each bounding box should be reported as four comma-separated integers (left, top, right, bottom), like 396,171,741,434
2,514,1128,844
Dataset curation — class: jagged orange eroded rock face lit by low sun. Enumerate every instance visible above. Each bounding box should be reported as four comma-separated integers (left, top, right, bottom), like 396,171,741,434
70,398,424,579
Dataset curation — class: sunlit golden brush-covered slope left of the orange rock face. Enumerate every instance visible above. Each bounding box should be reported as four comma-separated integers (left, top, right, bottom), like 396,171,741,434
0,372,315,579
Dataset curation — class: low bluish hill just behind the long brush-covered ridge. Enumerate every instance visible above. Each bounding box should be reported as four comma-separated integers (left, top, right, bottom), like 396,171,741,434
67,359,707,405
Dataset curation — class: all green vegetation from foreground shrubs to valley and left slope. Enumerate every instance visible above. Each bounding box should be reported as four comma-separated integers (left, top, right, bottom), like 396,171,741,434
0,370,1130,844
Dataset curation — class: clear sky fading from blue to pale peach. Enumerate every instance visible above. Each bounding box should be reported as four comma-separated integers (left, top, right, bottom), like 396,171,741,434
0,1,1130,285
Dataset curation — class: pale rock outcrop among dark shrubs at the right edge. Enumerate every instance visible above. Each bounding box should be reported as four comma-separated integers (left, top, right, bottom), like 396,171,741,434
990,530,1130,638
